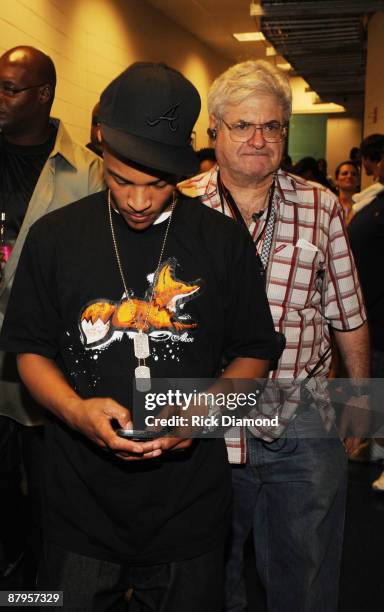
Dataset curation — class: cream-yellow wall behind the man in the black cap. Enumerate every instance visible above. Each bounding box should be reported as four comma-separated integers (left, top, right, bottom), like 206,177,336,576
0,0,229,148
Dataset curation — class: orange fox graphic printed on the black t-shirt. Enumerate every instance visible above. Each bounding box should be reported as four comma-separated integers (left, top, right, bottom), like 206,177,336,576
79,258,202,349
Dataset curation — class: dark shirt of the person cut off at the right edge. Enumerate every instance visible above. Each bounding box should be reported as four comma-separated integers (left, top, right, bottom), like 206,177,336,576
348,194,384,351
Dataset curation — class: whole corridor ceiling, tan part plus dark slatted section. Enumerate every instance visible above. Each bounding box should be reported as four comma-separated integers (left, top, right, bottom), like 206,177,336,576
147,0,384,114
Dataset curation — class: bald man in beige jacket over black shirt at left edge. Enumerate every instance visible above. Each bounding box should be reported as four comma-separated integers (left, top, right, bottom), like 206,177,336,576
0,46,103,586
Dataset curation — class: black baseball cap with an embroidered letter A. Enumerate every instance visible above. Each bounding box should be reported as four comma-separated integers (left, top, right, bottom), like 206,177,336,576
99,62,201,176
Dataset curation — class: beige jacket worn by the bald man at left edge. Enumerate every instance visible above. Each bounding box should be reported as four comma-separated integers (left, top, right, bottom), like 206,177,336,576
0,119,104,425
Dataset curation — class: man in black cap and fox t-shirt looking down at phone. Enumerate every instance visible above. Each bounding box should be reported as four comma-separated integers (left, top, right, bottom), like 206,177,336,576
2,63,276,612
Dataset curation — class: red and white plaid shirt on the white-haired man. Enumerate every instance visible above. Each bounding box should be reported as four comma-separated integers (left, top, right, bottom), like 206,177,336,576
179,167,366,463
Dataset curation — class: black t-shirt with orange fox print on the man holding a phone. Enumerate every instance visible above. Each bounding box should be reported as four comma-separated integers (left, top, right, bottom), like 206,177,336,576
1,193,276,563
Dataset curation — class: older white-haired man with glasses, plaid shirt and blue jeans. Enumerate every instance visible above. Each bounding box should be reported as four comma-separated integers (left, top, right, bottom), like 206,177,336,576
181,61,369,612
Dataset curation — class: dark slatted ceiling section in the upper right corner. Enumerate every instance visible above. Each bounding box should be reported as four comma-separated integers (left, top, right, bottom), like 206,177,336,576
256,0,384,113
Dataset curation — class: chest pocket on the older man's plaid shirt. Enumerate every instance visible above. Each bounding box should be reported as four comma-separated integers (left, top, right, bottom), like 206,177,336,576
268,244,322,310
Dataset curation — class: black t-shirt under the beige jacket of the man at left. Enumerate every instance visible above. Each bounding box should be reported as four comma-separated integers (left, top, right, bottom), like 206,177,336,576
0,125,57,242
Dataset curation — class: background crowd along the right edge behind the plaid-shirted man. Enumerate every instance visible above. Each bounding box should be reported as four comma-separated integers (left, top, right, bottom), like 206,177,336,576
282,140,384,492
